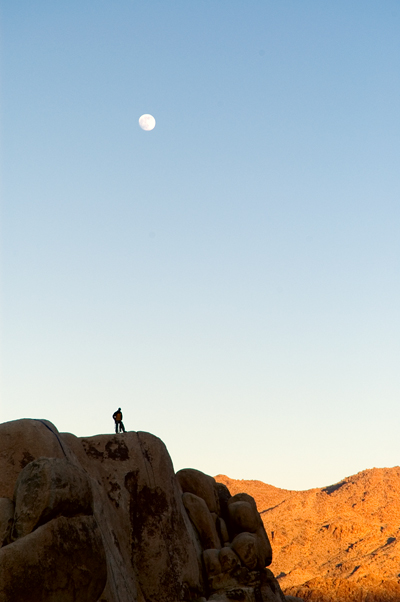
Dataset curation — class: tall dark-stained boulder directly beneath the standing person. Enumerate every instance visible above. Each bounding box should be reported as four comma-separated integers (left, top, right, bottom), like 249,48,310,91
62,432,203,602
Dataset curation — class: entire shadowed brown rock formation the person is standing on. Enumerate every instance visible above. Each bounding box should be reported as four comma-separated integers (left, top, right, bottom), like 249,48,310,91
0,420,284,602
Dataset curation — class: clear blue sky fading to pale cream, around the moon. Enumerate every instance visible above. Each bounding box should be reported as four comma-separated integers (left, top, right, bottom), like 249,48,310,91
0,0,400,489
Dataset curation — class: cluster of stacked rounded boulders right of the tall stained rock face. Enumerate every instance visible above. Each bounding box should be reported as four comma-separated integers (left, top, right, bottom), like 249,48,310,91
176,469,284,602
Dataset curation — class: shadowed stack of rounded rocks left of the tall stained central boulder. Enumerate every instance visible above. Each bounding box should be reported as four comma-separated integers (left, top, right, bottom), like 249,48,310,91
0,420,107,602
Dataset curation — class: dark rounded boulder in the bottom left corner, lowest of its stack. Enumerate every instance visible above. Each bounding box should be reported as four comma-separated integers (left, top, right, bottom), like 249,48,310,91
0,516,107,602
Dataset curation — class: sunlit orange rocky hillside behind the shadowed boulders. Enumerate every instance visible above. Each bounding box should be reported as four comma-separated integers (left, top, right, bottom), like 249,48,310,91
216,467,400,601
